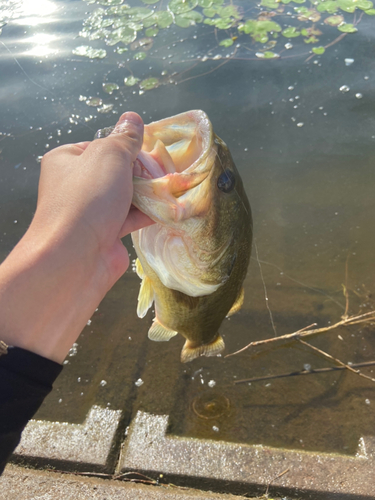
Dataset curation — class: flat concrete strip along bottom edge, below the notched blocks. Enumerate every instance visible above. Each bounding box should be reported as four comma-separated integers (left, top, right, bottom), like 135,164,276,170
0,465,253,500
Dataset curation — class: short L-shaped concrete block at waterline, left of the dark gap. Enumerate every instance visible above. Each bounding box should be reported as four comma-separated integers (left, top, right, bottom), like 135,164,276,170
13,406,121,471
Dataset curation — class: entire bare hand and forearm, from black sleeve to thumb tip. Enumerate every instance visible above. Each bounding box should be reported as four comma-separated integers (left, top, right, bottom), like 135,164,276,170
0,113,152,362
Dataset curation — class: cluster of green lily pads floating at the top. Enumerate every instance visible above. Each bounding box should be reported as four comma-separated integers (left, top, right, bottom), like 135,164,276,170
73,0,375,98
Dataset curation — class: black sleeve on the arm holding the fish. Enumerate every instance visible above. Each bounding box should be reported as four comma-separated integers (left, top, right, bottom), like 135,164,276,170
0,347,63,474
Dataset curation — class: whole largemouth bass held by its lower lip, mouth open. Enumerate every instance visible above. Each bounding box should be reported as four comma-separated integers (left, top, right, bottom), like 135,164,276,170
97,110,252,362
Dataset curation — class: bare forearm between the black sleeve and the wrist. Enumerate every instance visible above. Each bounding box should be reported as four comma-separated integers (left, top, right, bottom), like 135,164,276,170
0,220,114,363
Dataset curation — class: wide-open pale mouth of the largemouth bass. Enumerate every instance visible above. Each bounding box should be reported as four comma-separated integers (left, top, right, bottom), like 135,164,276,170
133,110,213,184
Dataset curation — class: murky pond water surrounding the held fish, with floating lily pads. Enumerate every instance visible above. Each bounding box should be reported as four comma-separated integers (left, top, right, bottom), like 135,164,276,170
0,0,375,454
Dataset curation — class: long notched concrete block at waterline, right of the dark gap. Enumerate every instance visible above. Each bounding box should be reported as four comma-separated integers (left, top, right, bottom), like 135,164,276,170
118,412,375,500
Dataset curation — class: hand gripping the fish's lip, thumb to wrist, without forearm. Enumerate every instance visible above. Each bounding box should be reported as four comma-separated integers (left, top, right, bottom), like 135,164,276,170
33,112,152,288
